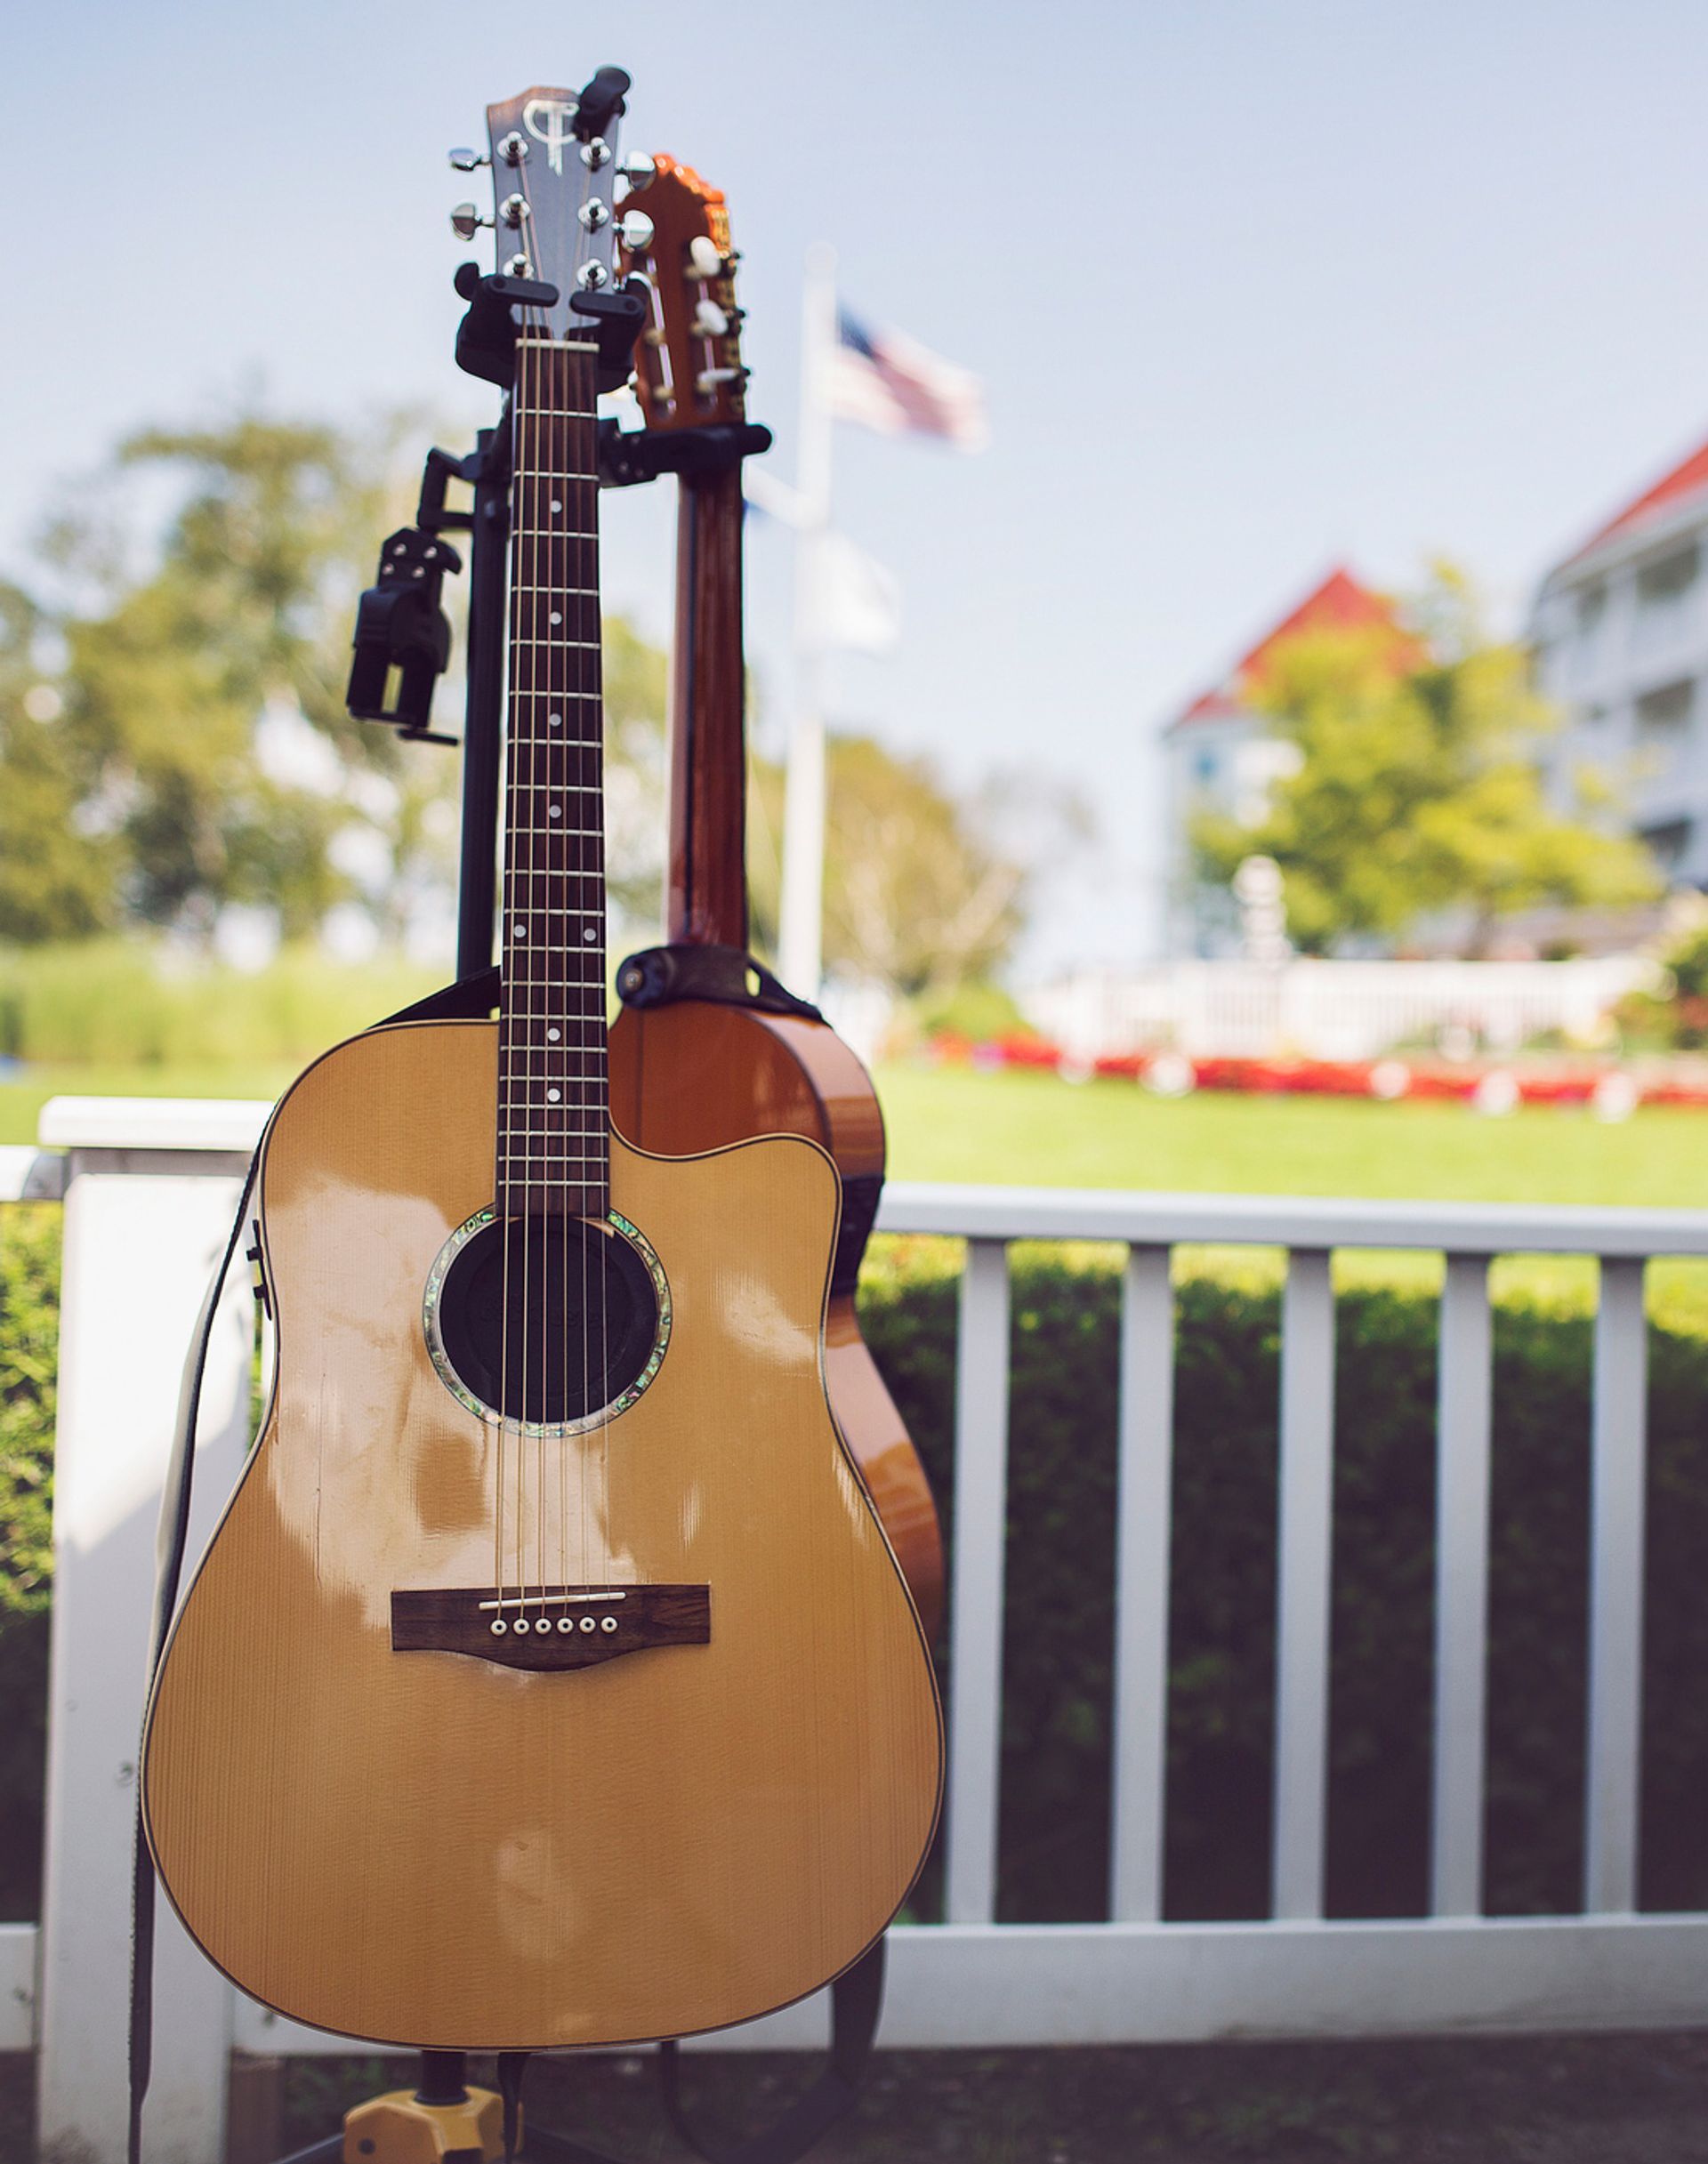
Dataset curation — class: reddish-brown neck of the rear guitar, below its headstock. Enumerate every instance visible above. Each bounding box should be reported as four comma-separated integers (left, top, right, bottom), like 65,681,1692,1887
665,468,747,948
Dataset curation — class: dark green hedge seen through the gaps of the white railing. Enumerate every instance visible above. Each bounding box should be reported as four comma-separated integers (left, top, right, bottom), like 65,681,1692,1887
0,1210,1708,1922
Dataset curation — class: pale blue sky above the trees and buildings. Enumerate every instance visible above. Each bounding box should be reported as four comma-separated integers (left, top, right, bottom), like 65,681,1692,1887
0,0,1708,959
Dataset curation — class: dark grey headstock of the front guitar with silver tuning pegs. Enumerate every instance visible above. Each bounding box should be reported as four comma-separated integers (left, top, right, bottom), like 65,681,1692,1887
450,67,645,338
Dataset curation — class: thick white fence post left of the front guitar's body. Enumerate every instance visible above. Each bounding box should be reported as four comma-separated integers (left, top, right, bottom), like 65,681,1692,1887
36,1099,255,2164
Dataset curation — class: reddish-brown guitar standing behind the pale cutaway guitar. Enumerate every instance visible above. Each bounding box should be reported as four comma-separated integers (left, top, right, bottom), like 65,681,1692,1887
610,158,944,1638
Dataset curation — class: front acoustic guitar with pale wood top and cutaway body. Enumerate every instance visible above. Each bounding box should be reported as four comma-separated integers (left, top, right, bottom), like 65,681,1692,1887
143,91,942,2049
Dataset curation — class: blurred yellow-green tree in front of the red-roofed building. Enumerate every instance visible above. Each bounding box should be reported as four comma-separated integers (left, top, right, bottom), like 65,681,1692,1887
1193,571,1656,953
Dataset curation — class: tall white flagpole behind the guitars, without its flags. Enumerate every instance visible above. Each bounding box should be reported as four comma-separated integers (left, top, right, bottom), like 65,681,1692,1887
777,242,835,1000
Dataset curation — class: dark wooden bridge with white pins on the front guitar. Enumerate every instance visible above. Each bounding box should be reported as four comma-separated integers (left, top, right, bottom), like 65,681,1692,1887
391,1586,713,1670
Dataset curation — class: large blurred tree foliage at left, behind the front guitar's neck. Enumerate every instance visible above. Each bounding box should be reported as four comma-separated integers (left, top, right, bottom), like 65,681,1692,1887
0,411,665,944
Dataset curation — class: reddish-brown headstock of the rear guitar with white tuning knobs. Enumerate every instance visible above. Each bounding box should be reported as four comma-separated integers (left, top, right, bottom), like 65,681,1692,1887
621,158,747,429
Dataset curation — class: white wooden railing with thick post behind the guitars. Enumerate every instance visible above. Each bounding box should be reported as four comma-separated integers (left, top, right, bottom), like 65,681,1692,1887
0,1099,1708,2164
